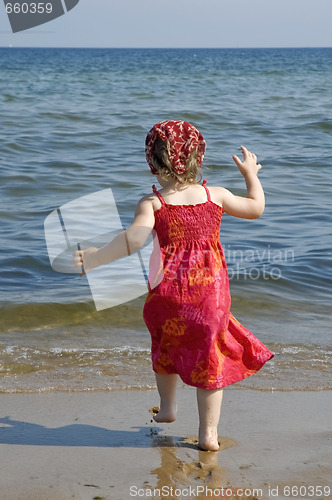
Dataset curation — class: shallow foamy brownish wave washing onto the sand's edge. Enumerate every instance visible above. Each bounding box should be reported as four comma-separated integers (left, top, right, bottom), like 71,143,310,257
0,342,332,393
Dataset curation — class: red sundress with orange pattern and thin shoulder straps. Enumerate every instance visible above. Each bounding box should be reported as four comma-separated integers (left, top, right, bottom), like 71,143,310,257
143,181,274,389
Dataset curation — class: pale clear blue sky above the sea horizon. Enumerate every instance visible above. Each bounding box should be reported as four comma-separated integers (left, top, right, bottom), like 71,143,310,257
0,0,332,47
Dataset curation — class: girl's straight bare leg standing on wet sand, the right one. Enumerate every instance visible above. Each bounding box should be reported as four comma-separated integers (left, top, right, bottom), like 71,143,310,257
197,389,223,451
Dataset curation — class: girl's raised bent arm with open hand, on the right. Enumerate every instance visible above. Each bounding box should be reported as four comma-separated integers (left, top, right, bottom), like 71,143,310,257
216,146,265,219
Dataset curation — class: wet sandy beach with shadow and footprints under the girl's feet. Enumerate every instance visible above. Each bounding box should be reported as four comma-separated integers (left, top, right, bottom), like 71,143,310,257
0,386,332,500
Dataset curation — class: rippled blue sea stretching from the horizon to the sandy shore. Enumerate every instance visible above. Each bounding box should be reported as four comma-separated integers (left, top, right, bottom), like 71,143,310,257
0,48,332,393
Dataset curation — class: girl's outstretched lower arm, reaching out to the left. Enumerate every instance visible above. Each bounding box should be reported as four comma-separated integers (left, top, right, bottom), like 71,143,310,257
72,197,154,272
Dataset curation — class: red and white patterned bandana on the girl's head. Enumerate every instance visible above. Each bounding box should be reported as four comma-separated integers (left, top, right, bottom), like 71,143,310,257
145,120,206,175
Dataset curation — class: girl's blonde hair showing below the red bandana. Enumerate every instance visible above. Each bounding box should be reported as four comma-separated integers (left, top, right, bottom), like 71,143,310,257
151,137,202,184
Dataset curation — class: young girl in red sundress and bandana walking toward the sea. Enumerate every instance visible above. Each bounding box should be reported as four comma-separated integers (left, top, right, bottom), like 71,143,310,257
74,121,273,451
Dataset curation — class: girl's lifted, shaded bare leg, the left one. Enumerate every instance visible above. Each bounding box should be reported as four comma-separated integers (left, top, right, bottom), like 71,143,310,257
153,373,178,422
